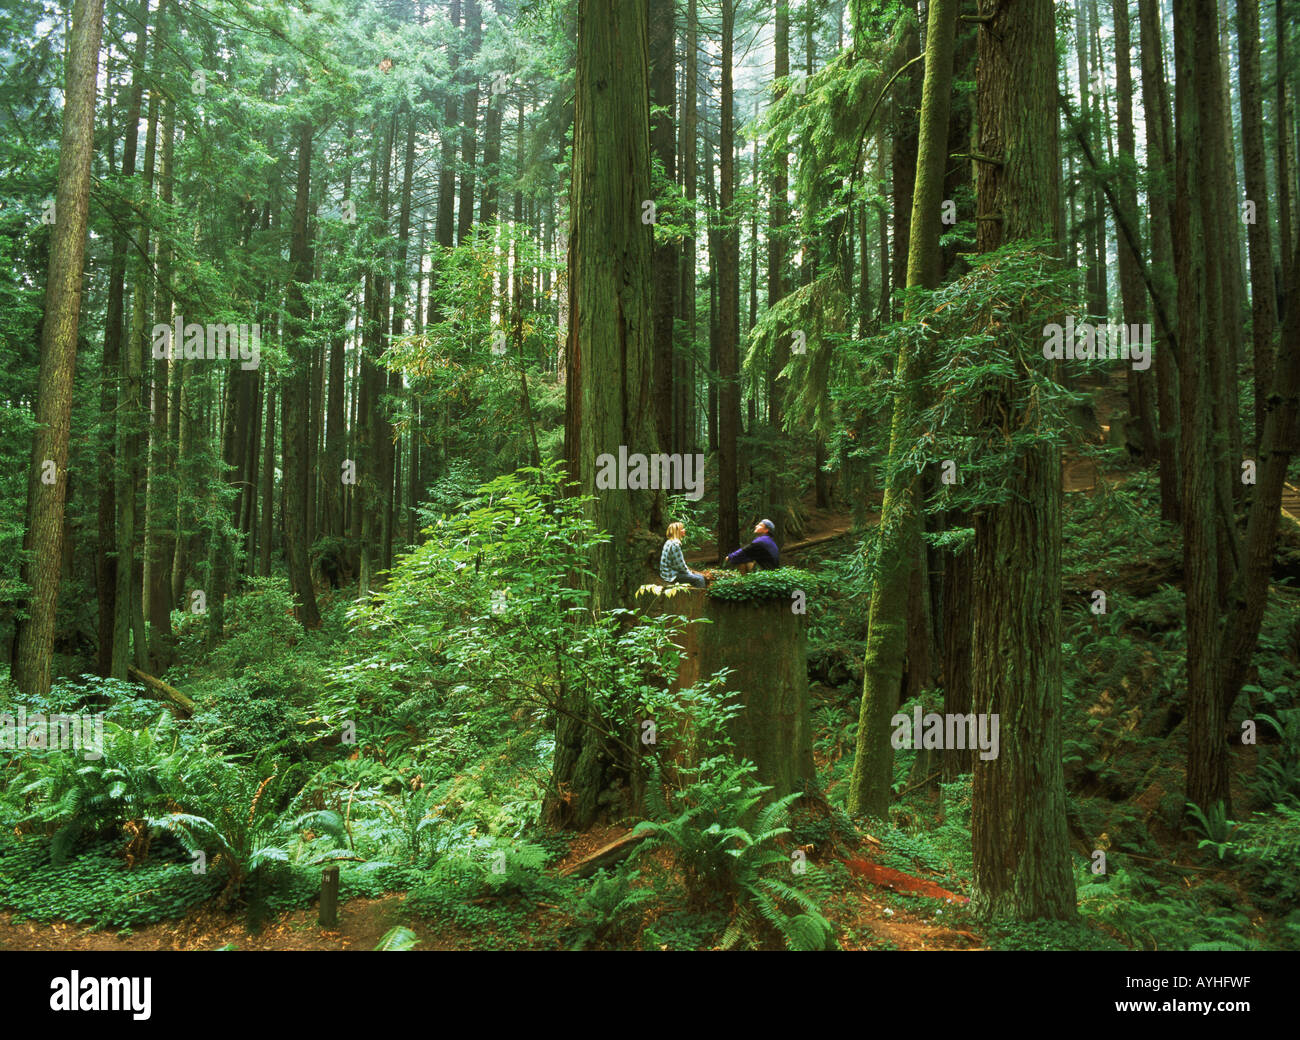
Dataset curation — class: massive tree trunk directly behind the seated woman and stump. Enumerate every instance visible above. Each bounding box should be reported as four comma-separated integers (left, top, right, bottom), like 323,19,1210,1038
545,0,658,828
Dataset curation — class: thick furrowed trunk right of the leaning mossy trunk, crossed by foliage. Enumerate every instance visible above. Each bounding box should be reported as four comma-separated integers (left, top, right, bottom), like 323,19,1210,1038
971,0,1075,920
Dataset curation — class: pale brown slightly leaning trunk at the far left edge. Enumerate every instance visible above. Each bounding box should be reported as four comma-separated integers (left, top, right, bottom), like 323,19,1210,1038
10,0,104,697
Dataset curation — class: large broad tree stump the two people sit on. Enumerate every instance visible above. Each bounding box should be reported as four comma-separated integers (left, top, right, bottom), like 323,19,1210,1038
642,589,816,798
